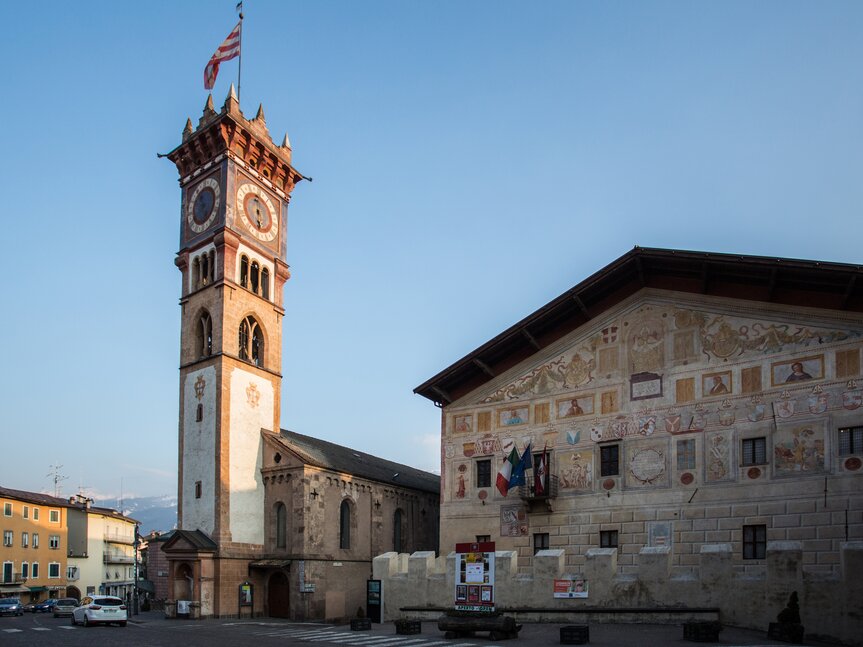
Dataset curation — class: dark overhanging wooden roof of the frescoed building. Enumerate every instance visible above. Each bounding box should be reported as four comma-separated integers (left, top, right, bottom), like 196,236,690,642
414,247,863,405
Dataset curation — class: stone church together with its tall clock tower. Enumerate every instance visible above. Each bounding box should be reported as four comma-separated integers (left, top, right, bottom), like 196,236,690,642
163,86,439,620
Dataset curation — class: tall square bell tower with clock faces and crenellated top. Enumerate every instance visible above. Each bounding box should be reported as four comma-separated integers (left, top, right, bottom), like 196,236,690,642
166,85,304,616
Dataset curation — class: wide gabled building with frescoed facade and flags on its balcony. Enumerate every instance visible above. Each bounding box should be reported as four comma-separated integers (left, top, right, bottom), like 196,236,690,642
415,247,863,576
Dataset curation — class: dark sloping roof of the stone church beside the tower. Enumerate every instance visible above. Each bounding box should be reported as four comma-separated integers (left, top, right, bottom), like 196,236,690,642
280,429,440,493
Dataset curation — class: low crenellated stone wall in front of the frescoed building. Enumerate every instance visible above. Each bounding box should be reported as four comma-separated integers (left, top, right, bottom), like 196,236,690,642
374,541,863,645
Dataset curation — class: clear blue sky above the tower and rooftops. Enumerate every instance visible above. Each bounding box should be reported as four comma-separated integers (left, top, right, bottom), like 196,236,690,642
0,0,863,498
